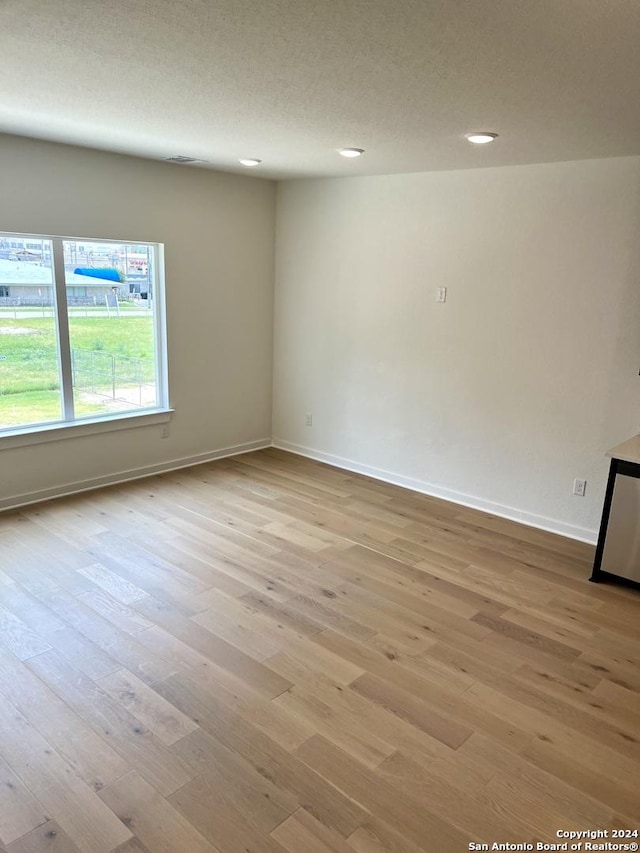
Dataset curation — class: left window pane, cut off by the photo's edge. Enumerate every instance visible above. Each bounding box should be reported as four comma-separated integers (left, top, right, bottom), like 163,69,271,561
0,233,62,429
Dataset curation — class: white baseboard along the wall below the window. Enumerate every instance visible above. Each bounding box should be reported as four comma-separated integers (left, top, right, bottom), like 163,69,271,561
0,438,271,510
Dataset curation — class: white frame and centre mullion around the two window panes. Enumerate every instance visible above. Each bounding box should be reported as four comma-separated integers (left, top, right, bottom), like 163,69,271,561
0,231,173,450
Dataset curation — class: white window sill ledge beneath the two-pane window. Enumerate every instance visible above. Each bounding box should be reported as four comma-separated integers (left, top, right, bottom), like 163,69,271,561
0,409,174,450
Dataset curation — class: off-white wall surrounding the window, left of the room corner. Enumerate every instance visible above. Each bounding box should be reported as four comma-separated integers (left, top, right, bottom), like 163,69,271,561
0,136,275,506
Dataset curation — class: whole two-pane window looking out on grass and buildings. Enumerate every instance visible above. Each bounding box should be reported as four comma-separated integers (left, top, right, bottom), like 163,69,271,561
0,233,168,437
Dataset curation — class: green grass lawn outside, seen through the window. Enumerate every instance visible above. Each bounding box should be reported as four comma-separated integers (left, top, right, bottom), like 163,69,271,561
0,316,154,428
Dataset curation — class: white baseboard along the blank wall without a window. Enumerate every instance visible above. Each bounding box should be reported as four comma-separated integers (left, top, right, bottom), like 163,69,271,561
272,438,598,545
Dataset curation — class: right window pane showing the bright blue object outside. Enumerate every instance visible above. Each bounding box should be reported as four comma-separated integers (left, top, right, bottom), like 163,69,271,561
63,240,159,417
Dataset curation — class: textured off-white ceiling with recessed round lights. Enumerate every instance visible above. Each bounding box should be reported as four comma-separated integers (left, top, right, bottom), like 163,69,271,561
0,0,640,178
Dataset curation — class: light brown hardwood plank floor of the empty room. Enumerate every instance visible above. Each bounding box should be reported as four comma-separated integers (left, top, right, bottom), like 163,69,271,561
0,450,640,853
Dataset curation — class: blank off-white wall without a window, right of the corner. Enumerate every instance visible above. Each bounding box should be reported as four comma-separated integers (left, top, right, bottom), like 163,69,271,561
273,158,640,538
